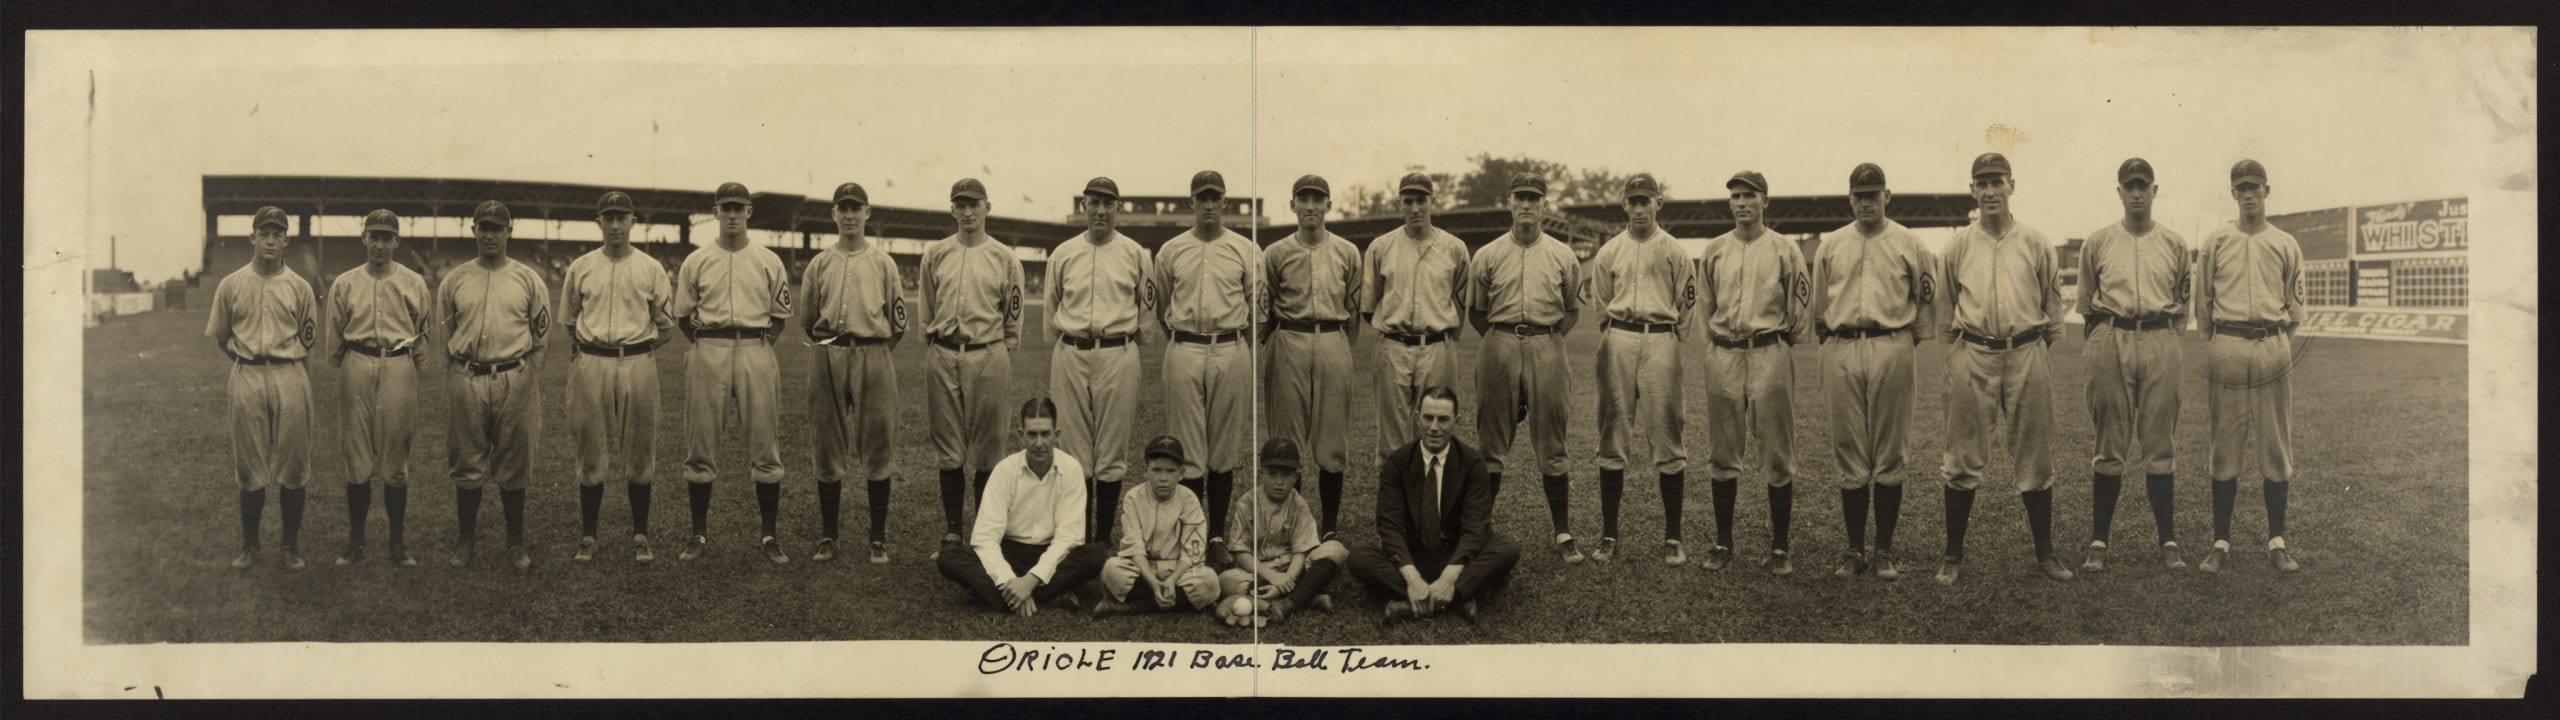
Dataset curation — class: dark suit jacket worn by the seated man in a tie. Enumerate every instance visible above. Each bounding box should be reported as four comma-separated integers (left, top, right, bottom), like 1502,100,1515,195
1377,438,1492,566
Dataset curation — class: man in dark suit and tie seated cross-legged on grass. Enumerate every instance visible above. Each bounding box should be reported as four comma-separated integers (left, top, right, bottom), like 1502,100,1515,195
1352,387,1521,623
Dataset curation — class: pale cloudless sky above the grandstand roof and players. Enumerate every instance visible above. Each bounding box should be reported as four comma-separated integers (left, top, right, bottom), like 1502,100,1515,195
28,28,2534,282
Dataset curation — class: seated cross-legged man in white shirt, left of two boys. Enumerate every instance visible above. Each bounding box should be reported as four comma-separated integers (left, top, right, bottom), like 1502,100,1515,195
934,397,1108,618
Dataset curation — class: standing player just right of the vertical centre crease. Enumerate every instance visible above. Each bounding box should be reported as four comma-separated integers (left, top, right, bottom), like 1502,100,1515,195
1262,174,1370,538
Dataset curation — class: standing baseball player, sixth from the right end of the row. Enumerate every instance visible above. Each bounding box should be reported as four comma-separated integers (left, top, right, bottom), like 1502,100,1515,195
1556,172,1697,566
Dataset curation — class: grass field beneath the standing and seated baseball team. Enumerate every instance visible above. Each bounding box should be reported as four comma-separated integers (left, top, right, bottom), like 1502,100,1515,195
82,284,2468,646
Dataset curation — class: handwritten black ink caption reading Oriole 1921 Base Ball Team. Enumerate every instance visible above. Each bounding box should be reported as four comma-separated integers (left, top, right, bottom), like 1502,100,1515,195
978,643,1431,674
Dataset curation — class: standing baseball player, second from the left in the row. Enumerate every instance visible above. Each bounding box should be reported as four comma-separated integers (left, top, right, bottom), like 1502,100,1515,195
328,210,435,566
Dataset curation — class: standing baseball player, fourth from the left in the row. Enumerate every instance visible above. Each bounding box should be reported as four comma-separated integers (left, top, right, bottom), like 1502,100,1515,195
561,190,676,564
